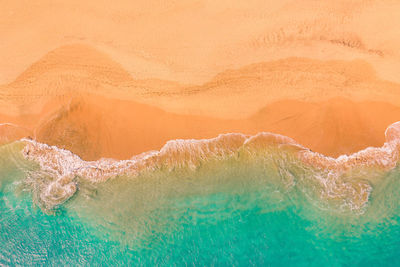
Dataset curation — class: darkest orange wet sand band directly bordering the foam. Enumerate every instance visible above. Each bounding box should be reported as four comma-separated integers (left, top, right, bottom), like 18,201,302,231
0,95,400,160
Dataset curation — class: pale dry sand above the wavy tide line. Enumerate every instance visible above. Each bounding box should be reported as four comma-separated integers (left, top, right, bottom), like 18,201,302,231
0,0,400,84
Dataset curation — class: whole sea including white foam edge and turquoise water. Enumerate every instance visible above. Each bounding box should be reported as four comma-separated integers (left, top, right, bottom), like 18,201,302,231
0,126,400,266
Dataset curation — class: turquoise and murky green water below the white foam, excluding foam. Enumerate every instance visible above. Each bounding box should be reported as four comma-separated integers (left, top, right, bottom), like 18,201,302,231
0,141,400,266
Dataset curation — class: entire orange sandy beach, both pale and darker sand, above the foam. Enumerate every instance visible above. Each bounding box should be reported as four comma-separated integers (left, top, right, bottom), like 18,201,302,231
0,1,400,160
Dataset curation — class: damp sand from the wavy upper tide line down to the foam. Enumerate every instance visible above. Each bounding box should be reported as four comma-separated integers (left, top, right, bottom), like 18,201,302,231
0,45,400,160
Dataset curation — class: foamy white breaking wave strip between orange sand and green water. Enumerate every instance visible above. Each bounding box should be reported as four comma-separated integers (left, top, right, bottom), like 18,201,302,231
14,122,400,212
